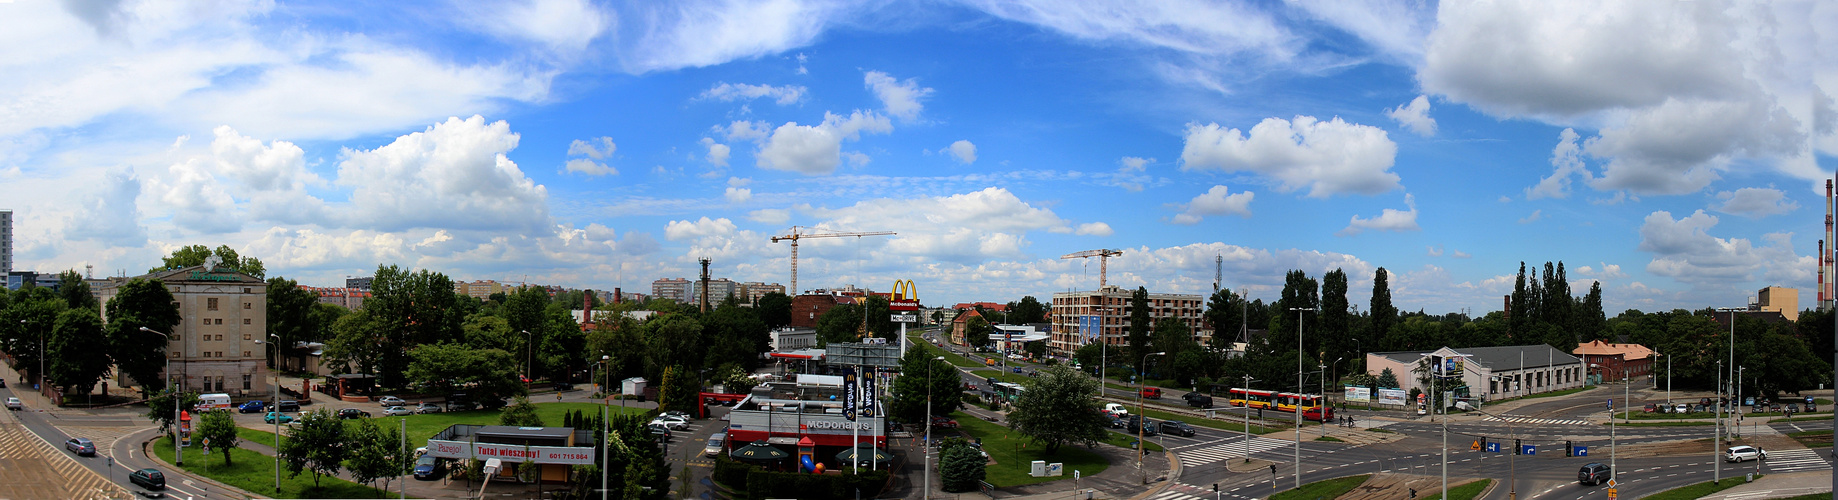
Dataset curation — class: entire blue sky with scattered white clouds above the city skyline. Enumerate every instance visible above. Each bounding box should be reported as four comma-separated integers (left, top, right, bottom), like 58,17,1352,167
0,0,1838,314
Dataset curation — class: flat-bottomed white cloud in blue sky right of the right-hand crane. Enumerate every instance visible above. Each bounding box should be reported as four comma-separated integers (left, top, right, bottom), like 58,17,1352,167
1180,116,1399,197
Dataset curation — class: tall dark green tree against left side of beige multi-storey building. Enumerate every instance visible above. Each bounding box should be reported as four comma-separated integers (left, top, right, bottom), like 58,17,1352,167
107,278,180,395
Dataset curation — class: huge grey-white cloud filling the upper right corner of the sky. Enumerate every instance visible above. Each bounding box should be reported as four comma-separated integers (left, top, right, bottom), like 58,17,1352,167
1417,0,1831,197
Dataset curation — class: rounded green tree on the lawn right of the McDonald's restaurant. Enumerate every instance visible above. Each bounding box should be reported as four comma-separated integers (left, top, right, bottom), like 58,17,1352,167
1009,366,1110,454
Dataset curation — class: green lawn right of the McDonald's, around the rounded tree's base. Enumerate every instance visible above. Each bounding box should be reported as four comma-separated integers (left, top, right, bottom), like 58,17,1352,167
952,412,1114,487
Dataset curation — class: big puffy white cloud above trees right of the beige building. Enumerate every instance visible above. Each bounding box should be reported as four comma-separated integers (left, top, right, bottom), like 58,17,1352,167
338,116,550,233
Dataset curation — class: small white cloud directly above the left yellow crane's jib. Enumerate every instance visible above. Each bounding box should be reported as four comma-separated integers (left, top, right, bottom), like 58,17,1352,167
754,110,893,175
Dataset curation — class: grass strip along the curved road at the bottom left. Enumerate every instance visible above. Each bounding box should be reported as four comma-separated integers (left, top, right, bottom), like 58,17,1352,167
151,438,384,498
